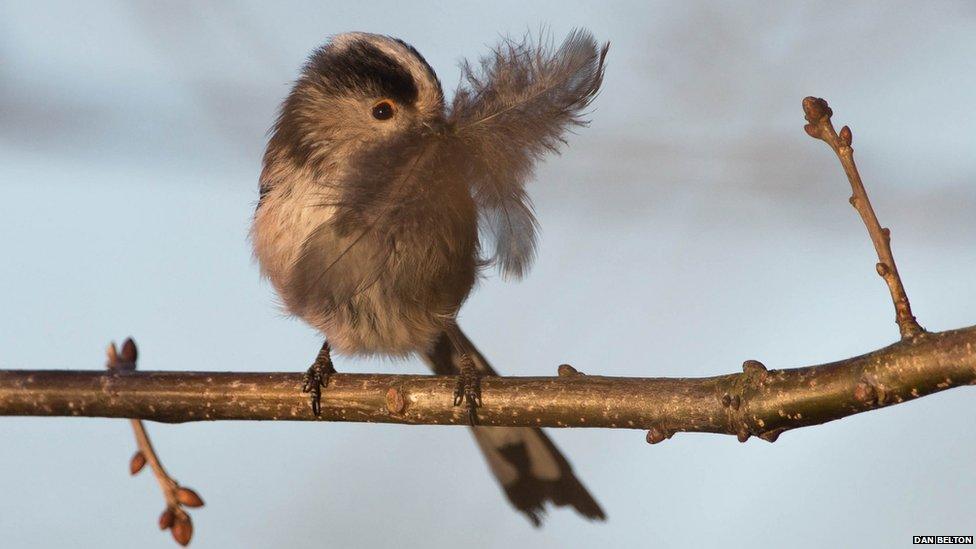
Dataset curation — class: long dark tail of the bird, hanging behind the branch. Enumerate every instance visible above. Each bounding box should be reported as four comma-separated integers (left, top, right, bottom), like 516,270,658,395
423,329,606,526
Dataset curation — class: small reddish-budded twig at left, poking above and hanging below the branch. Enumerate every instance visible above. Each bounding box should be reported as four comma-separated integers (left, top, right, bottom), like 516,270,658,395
105,338,203,546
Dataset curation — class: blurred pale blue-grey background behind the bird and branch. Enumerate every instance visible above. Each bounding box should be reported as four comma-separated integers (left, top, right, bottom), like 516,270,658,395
0,0,976,549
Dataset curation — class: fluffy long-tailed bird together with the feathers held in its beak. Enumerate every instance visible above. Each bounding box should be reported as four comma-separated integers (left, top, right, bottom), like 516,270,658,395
250,29,609,526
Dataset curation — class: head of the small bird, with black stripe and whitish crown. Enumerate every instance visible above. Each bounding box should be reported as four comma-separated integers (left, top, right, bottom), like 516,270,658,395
265,32,445,169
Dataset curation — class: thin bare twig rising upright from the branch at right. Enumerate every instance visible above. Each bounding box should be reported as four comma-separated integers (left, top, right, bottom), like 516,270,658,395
803,97,925,340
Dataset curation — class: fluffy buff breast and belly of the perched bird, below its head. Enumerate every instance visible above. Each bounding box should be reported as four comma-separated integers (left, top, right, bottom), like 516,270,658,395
252,163,478,355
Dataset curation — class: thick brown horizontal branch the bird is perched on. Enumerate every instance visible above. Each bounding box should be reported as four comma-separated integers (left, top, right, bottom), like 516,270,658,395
0,326,976,442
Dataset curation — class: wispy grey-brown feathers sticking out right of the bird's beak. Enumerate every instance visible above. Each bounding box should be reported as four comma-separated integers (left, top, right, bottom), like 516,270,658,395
449,30,610,278
